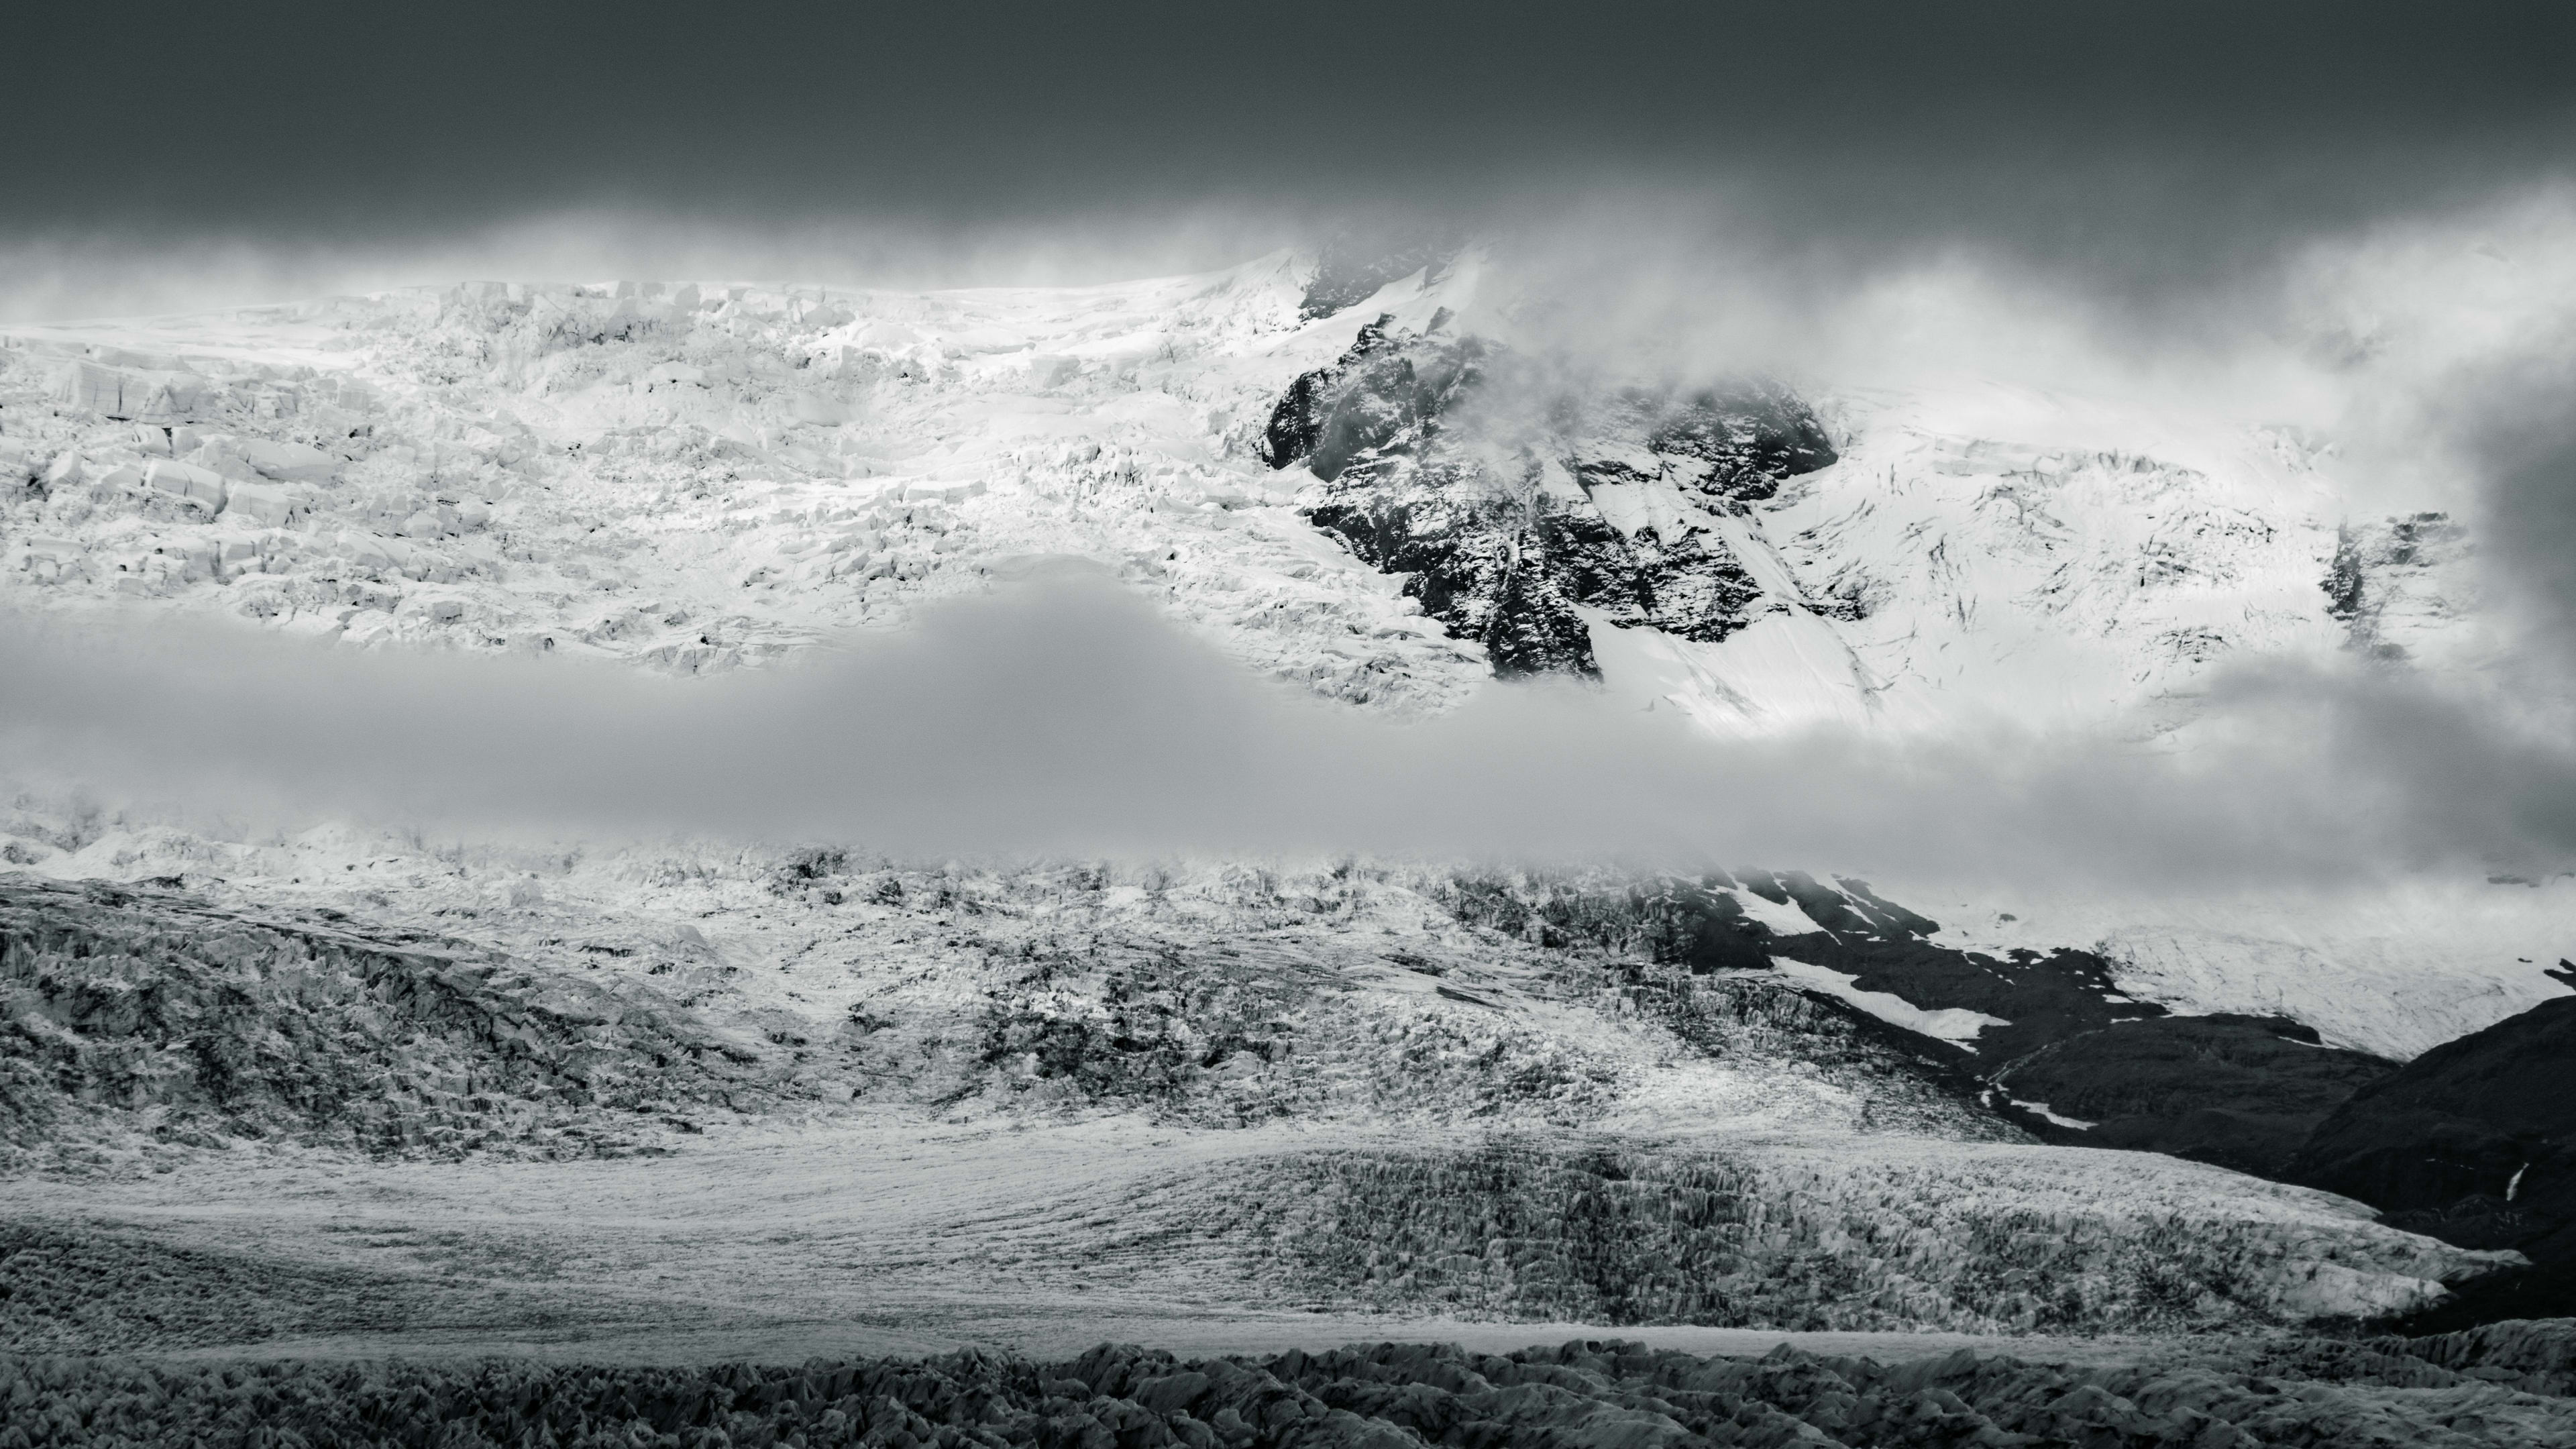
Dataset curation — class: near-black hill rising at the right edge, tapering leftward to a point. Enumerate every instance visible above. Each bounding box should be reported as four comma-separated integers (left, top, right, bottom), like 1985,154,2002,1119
2288,998,2576,1263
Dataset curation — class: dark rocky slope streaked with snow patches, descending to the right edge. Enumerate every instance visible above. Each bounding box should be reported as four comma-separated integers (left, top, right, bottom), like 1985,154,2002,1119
1458,869,2576,1273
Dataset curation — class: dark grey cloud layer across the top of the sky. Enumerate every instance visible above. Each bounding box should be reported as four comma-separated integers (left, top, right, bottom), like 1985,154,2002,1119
15,0,2576,273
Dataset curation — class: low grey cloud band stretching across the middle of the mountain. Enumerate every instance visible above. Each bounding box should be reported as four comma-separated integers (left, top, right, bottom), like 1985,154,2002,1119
0,580,2576,890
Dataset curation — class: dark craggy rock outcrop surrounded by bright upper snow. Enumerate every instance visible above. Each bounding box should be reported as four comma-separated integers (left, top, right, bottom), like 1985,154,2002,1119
1263,317,1834,676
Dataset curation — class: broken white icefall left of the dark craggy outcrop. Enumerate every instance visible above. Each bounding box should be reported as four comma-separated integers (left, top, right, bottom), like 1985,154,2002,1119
0,258,1481,706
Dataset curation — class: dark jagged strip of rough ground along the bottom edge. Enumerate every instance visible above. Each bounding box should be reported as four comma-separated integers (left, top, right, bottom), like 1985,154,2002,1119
0,1341,2576,1449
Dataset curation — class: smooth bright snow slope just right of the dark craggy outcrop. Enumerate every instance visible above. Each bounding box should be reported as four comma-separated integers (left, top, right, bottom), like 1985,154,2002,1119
1764,387,2342,722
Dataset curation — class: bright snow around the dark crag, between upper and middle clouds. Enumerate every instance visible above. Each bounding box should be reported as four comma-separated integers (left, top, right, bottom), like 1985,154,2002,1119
0,253,2471,733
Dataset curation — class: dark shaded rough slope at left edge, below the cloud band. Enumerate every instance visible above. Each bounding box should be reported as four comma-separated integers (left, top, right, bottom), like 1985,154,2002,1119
0,861,796,1155
